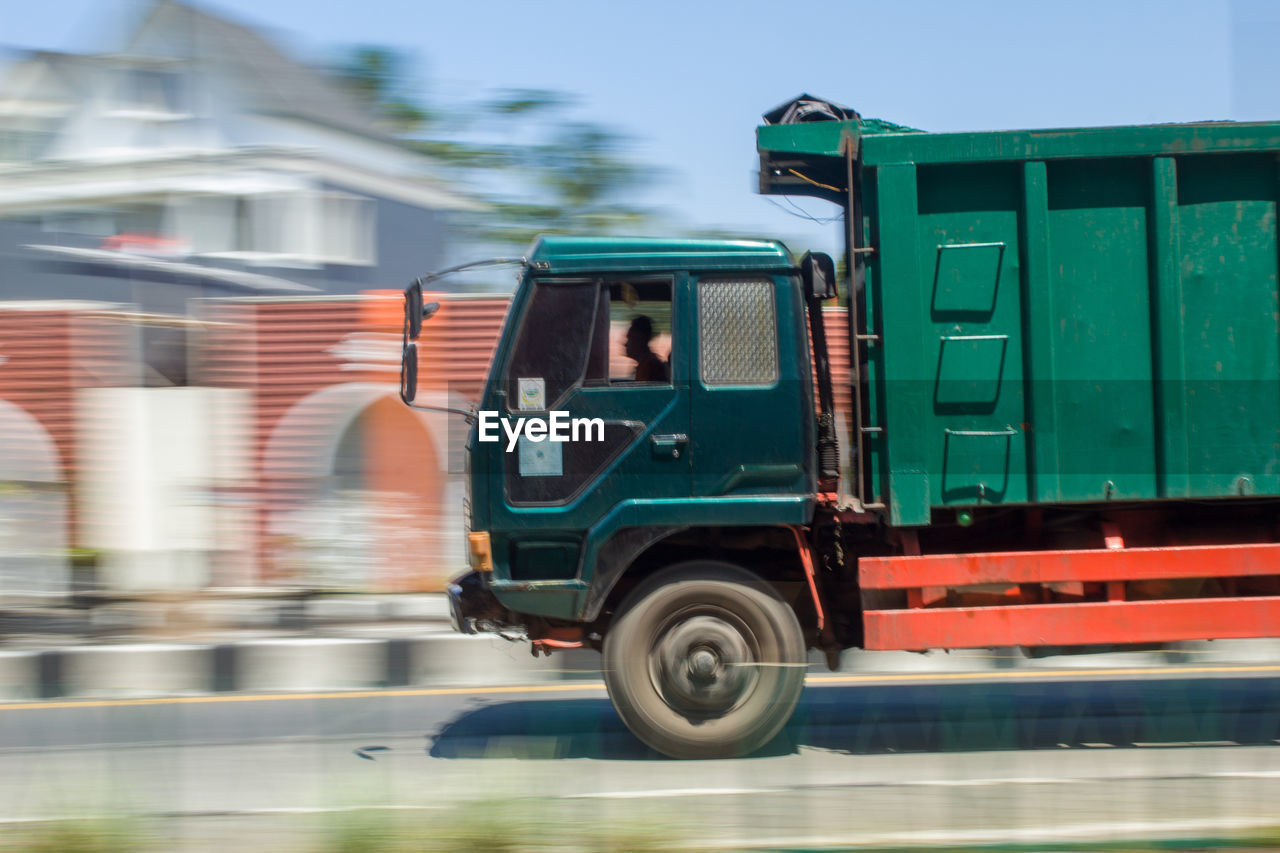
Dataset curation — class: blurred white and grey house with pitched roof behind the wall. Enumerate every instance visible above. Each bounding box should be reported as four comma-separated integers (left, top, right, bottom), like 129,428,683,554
0,0,471,302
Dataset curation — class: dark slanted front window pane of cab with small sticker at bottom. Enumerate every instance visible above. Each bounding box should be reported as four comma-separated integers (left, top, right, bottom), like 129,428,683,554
503,282,599,411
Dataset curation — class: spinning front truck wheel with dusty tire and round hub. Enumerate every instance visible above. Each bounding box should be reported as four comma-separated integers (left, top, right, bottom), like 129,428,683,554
603,561,805,758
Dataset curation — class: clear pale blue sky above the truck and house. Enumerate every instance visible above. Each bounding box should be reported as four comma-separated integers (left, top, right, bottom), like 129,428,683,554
0,0,1280,248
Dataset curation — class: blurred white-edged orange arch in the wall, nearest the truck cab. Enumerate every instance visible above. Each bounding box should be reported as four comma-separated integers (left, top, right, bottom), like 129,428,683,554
262,383,461,590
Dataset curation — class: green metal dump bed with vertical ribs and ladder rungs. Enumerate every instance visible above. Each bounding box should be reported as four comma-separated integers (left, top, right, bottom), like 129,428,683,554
758,113,1280,525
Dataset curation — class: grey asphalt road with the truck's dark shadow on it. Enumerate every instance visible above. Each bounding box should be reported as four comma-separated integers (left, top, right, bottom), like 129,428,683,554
0,666,1280,850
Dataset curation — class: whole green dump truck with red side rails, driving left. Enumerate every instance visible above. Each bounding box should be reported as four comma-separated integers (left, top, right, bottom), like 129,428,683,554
402,96,1280,757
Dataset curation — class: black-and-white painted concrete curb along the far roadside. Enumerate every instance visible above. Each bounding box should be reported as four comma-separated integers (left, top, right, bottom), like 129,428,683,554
0,633,1280,702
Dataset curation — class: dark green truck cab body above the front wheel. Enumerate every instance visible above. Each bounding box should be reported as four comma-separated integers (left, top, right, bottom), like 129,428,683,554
467,237,814,607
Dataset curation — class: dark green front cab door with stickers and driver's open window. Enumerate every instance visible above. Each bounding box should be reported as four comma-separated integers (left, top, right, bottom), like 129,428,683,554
488,275,690,583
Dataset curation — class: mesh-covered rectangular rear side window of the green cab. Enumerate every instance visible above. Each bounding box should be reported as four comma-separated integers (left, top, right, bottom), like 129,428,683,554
698,278,778,387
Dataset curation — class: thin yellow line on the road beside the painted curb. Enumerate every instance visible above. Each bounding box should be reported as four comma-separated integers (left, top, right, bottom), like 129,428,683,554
0,663,1280,711
